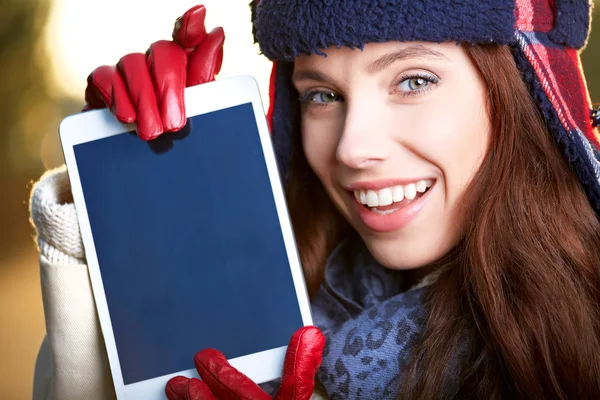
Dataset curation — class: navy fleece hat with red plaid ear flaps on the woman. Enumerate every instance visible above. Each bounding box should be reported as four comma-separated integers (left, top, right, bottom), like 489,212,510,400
251,0,600,216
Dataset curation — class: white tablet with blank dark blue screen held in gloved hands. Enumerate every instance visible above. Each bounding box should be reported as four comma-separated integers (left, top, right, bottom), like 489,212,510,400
60,77,312,400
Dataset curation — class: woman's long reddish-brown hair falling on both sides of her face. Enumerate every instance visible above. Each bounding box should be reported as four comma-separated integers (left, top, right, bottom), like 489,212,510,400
288,45,600,400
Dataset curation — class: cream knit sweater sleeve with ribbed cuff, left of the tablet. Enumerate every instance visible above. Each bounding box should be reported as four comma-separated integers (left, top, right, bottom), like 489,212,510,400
30,167,115,400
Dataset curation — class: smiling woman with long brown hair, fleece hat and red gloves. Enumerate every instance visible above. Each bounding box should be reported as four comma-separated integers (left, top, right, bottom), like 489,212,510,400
32,0,600,399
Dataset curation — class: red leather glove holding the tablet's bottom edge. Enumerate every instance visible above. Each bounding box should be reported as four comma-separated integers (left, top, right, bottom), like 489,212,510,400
165,326,325,400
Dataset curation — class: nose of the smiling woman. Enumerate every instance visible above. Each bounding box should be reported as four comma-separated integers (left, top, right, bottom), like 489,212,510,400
336,104,391,169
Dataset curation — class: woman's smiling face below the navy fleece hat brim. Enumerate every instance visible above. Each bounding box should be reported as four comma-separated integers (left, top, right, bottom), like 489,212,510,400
293,42,490,269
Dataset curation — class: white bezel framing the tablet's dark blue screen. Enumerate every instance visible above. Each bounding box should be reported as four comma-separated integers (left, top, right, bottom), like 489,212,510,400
59,76,312,400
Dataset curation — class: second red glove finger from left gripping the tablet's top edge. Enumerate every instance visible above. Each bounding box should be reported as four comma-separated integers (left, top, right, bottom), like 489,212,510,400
117,53,163,140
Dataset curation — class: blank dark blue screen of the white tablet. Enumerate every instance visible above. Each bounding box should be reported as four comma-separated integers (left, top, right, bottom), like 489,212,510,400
74,103,303,384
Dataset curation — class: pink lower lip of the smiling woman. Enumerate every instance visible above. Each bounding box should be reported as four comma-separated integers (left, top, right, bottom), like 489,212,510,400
348,181,437,233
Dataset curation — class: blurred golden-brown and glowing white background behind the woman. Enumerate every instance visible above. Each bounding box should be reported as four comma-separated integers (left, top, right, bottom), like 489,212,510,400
0,0,600,399
